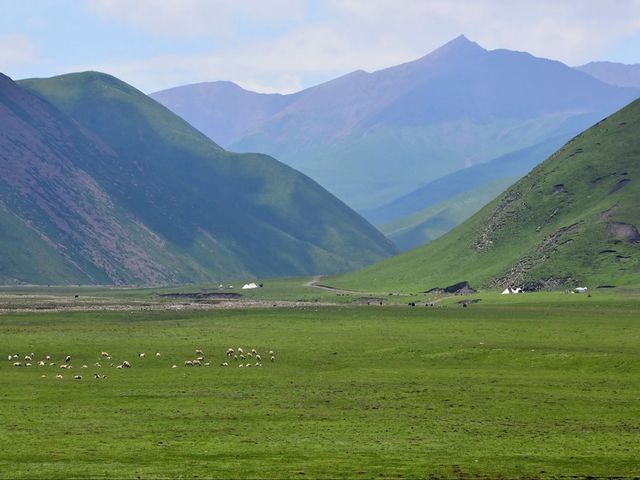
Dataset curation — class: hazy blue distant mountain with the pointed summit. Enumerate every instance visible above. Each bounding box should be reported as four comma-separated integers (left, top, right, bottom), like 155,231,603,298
153,36,640,212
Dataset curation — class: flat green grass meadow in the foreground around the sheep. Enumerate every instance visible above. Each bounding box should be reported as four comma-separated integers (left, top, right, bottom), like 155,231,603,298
0,290,640,478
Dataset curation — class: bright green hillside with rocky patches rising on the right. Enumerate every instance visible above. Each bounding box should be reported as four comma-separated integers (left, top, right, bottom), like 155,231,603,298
329,100,640,292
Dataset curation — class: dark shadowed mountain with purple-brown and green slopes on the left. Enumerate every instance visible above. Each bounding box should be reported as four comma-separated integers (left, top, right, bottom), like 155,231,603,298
0,72,393,284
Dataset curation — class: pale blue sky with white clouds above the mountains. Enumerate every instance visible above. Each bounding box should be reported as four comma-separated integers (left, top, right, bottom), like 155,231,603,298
0,0,640,93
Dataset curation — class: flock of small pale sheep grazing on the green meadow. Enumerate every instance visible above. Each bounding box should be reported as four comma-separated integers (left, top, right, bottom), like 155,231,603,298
7,347,276,380
